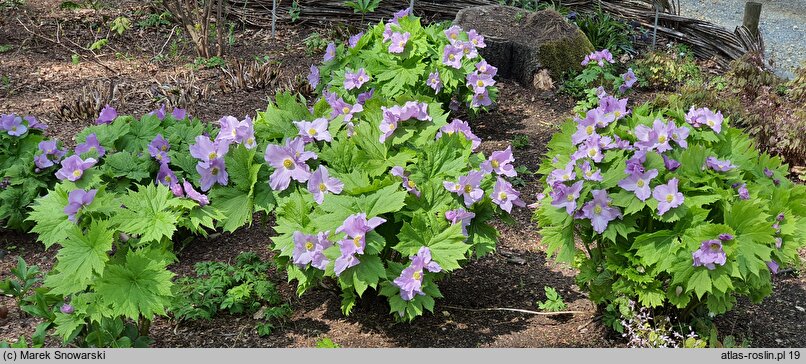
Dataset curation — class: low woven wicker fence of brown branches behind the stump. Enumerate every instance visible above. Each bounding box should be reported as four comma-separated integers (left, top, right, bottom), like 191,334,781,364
229,0,764,66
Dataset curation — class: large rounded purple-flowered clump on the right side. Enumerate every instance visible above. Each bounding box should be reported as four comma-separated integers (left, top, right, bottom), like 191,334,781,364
536,89,806,322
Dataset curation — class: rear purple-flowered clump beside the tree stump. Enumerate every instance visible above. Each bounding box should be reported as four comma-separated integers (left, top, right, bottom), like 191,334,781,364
308,10,498,116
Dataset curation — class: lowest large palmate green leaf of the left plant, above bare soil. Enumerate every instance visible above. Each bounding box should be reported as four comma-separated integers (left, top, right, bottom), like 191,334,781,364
96,251,174,320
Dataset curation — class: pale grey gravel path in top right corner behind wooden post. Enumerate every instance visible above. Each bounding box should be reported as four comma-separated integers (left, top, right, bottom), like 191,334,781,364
680,0,806,78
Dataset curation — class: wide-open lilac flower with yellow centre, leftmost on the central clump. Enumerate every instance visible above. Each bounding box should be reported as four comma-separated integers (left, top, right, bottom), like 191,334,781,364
264,138,316,191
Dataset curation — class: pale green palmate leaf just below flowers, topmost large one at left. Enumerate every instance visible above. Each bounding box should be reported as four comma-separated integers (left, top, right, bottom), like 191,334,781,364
112,184,180,244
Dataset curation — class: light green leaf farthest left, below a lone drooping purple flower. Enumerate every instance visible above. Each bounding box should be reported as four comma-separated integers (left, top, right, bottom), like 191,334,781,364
28,183,75,249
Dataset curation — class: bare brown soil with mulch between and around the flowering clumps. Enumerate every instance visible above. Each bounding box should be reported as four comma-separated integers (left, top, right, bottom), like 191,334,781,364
0,0,806,347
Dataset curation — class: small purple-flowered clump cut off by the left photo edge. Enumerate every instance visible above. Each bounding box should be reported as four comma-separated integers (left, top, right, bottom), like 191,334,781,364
0,114,59,231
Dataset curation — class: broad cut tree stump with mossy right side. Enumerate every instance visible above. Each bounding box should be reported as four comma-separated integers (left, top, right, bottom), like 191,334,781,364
453,5,593,86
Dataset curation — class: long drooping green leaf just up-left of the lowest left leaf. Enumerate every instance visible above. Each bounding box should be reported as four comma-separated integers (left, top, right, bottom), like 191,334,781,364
45,220,114,296
